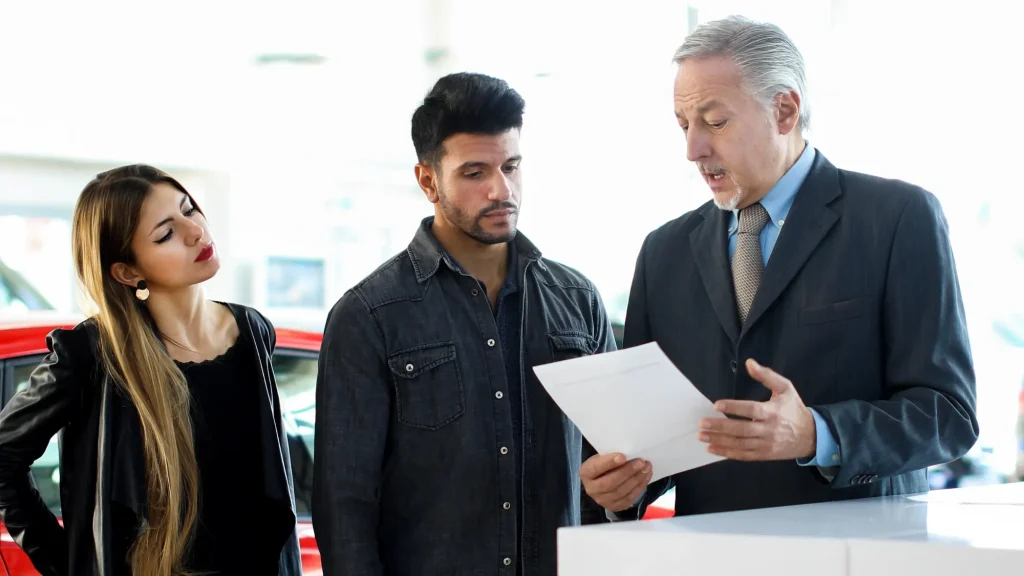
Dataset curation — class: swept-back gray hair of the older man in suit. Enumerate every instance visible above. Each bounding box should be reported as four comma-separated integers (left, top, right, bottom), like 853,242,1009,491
672,16,811,131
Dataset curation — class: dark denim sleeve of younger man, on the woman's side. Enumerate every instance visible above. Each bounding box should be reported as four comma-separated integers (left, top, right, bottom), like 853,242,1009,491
312,291,391,576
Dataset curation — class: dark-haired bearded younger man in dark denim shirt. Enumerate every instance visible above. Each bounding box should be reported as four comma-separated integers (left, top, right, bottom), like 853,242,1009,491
312,74,614,576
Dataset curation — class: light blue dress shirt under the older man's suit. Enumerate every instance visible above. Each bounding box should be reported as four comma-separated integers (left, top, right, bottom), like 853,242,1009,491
729,142,842,467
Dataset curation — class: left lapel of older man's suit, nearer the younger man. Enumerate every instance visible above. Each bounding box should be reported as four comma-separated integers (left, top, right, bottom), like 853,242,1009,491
690,204,739,345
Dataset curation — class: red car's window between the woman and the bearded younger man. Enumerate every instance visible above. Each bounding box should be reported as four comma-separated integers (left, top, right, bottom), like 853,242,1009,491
273,348,316,518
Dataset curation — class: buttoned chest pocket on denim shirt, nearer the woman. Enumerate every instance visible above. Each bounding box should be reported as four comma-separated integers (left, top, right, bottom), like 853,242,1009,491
387,342,466,430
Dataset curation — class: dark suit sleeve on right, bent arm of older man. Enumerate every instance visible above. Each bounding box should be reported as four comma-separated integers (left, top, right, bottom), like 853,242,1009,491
815,191,978,488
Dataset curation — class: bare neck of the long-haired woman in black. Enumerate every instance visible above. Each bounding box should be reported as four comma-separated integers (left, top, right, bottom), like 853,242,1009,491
146,285,217,349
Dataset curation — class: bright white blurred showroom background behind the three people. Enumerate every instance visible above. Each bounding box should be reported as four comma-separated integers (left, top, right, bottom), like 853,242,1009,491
0,0,1024,487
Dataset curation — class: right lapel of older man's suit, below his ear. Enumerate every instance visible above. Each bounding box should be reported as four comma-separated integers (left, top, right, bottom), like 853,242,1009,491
740,152,842,336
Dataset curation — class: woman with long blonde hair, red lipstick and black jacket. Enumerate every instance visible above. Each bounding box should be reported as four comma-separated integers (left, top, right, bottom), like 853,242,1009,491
0,166,301,576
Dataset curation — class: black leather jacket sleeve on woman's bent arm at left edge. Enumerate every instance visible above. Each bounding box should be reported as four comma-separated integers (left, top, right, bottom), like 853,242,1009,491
0,330,83,576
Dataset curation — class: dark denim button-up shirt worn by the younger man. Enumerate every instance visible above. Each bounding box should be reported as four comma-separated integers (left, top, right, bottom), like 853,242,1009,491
312,218,614,576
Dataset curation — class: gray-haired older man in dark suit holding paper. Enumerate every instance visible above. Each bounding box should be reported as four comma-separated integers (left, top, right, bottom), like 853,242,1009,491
581,16,978,520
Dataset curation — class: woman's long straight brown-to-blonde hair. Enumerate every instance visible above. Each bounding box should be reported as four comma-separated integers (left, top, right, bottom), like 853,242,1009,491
72,165,199,576
